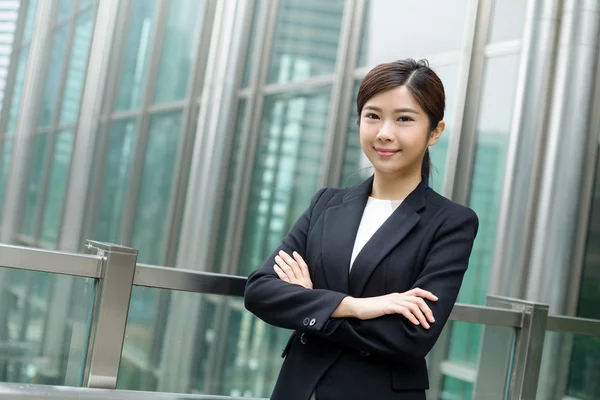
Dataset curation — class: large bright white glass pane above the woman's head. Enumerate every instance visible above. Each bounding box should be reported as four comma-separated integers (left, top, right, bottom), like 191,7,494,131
358,0,472,67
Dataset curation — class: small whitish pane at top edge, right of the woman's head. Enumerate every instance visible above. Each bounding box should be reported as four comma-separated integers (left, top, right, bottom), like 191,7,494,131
488,0,527,43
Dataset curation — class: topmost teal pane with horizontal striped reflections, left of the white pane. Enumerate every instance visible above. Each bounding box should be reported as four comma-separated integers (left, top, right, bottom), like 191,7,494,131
267,0,344,83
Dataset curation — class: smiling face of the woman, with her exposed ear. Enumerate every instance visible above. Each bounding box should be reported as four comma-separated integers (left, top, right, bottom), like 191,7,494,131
360,86,444,175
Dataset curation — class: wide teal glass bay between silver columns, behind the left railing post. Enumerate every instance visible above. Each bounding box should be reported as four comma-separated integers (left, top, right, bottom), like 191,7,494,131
87,0,212,390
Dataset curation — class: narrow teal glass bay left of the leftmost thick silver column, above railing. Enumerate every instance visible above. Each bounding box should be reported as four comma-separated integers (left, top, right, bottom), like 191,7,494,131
17,1,96,248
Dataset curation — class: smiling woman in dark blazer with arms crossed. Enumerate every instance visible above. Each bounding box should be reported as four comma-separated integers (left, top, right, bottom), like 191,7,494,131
245,59,478,400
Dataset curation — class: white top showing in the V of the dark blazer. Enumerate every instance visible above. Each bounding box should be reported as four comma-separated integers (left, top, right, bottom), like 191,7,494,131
350,196,402,269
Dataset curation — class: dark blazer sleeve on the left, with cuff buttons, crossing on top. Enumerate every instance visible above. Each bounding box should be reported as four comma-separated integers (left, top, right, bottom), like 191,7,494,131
244,189,347,333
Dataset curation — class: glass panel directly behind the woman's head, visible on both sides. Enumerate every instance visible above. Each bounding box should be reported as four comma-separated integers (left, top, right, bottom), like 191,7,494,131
341,64,458,192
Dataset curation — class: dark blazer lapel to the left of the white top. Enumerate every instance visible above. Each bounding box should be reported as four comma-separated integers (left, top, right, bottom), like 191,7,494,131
322,177,373,293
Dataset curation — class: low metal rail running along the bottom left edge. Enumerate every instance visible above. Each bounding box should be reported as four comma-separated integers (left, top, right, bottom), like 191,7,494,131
0,383,266,400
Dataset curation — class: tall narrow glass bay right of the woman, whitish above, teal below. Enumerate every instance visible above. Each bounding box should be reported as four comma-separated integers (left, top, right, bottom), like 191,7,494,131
443,1,527,399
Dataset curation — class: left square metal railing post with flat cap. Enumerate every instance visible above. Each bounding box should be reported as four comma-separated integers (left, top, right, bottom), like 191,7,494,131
84,241,138,389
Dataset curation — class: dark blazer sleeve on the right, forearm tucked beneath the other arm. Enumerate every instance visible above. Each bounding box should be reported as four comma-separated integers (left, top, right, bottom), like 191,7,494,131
319,208,479,361
